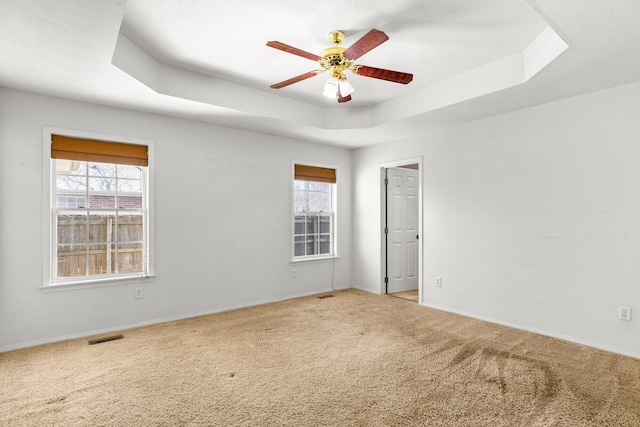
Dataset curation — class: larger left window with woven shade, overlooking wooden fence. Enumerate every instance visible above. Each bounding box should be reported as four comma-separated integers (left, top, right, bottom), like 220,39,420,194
49,134,150,285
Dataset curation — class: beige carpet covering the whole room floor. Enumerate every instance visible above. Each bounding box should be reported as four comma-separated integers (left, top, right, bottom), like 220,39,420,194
0,290,640,427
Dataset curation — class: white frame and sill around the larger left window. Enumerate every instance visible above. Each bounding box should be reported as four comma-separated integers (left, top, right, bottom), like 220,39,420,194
41,126,155,291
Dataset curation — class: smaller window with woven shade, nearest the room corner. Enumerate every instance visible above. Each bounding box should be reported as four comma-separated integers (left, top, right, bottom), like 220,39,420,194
293,164,336,260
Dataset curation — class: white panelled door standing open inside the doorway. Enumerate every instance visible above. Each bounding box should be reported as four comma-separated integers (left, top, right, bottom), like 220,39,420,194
387,168,419,293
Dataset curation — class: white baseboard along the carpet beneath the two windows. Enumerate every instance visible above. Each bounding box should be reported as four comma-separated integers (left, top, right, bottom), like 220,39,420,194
0,288,336,353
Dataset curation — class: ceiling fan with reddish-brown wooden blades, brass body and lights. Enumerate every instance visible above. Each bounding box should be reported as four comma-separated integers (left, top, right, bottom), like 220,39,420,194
267,29,413,102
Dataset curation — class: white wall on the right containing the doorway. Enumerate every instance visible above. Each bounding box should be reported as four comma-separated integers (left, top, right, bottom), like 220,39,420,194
352,79,640,357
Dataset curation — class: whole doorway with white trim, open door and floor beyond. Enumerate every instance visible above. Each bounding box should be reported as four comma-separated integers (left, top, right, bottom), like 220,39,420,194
381,158,422,303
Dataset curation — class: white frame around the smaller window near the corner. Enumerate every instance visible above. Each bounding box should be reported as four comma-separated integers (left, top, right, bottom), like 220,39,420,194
289,159,340,263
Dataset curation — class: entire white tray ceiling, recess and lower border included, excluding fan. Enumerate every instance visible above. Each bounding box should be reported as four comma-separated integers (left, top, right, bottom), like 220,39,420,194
0,0,640,147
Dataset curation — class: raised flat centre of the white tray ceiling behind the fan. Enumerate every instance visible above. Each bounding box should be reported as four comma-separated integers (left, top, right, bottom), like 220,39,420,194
122,0,546,106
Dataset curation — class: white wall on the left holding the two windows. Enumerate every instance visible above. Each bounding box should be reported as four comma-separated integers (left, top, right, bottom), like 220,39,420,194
0,89,352,351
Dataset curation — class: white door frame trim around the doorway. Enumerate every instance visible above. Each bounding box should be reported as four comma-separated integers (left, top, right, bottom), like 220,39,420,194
378,156,424,304
